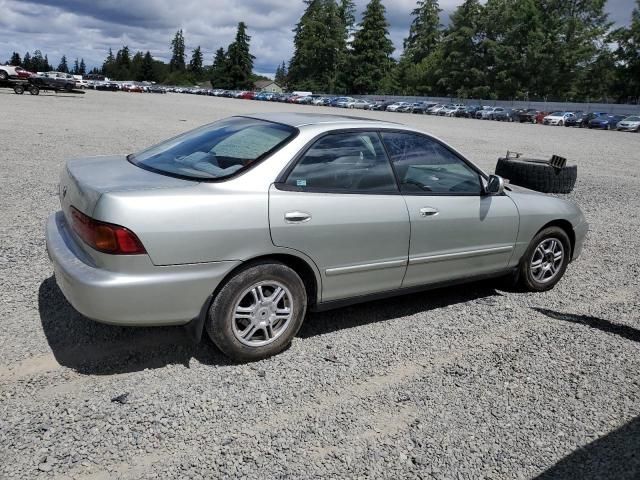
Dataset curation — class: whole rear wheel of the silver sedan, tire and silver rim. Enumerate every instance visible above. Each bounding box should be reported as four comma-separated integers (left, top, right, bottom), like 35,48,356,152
206,262,307,362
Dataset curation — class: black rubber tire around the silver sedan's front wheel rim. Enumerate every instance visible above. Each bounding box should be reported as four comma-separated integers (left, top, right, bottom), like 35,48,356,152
518,227,572,292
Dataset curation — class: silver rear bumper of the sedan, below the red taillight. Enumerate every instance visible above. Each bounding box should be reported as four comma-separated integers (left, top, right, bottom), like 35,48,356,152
46,212,240,326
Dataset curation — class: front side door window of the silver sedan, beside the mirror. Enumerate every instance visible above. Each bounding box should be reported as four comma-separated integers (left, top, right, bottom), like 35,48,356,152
382,132,481,195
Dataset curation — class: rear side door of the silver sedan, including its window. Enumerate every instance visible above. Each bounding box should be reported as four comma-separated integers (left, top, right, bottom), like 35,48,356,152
269,131,409,301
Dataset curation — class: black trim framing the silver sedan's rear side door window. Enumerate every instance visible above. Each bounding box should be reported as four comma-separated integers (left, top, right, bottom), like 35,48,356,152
273,128,402,196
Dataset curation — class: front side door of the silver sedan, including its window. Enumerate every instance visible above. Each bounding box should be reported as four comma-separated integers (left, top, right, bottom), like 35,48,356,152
381,132,519,287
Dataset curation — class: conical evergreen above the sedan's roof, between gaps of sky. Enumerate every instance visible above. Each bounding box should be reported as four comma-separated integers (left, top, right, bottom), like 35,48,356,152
349,0,394,93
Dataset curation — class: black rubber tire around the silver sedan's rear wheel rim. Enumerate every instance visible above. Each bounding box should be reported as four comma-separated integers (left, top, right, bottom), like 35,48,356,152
205,261,307,362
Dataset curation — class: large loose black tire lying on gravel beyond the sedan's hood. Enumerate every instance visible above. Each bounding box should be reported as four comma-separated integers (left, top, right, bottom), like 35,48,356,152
496,158,578,193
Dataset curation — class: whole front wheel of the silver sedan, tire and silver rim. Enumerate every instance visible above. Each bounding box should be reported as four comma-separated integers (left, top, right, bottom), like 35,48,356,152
519,227,571,292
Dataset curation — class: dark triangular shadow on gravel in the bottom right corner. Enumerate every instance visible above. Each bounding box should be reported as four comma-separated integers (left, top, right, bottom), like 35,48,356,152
536,417,640,480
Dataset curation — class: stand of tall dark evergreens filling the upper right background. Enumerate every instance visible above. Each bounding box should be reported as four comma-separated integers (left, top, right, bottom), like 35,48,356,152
288,0,640,102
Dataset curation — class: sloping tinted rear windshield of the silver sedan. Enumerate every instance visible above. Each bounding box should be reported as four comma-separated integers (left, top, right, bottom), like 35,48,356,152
128,117,296,180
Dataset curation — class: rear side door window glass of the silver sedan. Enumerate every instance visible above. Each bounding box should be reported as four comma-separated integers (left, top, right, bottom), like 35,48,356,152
286,132,397,193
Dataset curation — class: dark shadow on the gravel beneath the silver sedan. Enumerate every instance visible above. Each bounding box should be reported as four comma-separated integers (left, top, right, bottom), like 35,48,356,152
38,276,500,375
